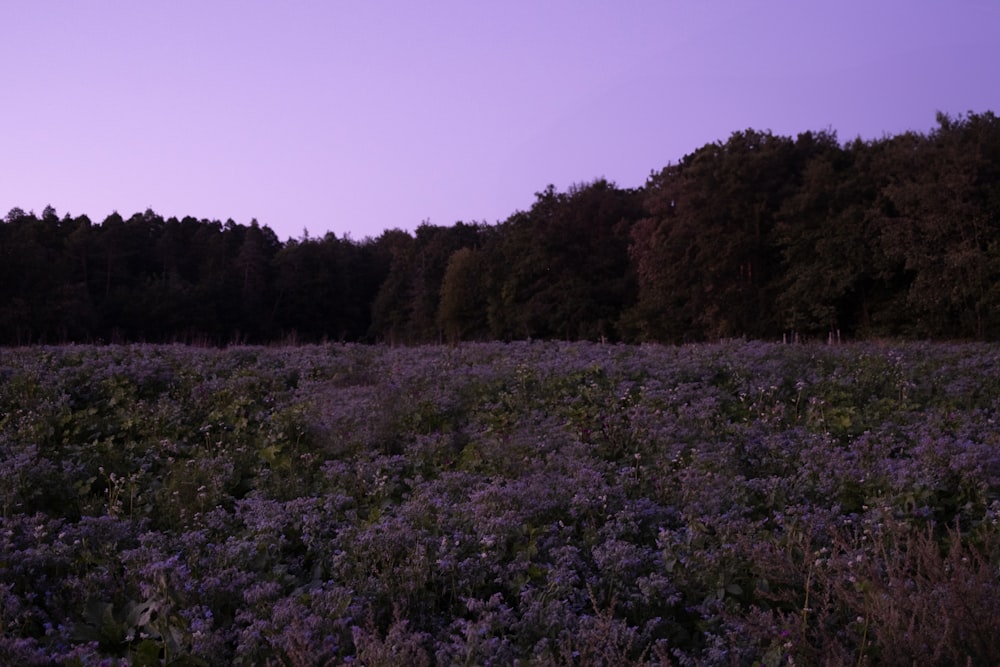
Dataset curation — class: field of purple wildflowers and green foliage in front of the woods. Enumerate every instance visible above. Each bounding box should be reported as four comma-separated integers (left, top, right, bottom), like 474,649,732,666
0,342,1000,667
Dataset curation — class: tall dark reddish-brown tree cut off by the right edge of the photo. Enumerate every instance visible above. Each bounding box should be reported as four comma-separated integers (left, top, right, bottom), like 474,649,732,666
882,113,1000,338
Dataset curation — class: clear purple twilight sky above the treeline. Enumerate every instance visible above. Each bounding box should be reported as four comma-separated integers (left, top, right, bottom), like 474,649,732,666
0,0,1000,240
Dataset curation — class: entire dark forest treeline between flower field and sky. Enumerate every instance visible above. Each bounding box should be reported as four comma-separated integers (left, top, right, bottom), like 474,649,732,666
0,112,1000,345
